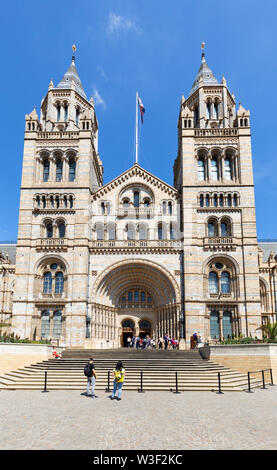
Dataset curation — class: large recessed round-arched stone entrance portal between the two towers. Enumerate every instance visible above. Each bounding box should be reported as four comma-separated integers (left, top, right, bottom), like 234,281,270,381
91,259,181,347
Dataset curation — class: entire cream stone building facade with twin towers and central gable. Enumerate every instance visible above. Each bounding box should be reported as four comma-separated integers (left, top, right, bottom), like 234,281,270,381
2,47,276,348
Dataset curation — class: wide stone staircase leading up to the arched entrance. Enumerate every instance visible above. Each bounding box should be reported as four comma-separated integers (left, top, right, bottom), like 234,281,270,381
0,348,262,392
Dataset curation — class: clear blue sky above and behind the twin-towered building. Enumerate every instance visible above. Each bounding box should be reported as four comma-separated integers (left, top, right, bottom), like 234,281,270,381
0,0,277,240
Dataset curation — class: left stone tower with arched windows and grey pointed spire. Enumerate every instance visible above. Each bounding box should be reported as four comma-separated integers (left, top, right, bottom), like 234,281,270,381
13,46,103,343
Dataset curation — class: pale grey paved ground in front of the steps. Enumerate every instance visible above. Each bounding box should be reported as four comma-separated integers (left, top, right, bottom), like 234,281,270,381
0,386,277,450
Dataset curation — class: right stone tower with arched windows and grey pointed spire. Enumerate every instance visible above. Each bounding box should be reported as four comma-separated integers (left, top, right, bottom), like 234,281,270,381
174,43,261,340
